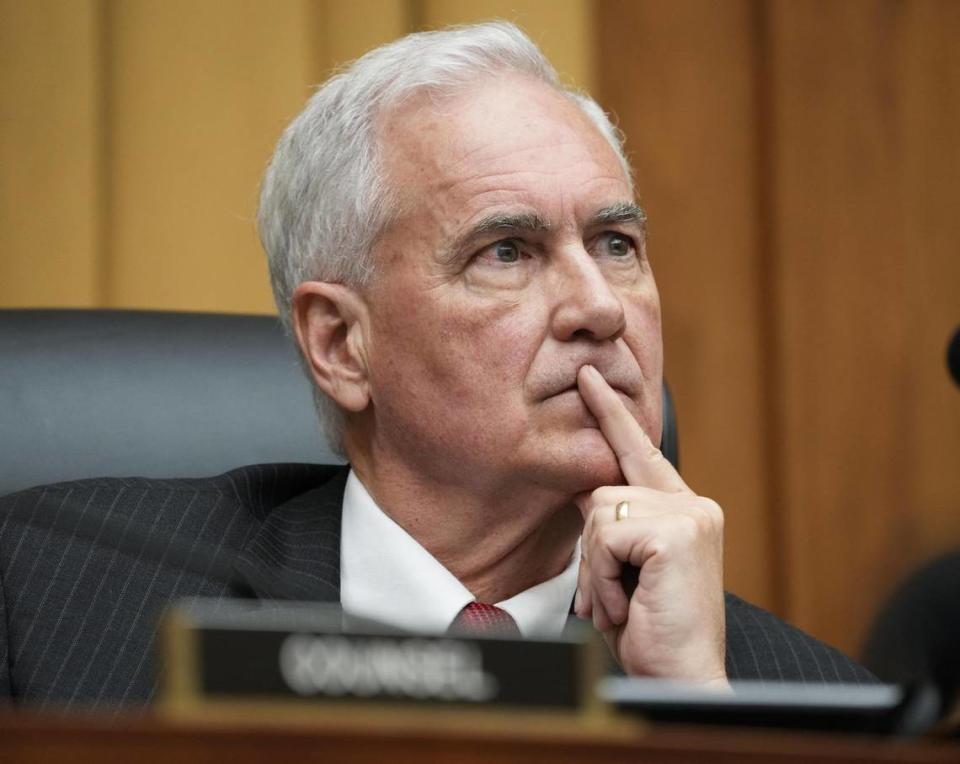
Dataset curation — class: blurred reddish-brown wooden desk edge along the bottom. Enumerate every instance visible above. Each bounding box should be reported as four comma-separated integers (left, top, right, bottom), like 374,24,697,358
0,711,960,764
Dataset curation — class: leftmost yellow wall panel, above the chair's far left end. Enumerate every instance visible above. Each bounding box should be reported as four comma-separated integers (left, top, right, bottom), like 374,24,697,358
0,0,102,307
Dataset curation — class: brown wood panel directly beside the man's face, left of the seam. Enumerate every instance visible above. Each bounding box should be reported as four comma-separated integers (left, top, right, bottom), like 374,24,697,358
595,0,777,607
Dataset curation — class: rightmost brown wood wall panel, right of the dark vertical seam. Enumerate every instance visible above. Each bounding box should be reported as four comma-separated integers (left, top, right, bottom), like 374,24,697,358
767,2,960,650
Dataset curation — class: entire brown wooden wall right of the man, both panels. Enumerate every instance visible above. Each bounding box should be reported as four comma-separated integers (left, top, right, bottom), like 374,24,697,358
595,0,960,651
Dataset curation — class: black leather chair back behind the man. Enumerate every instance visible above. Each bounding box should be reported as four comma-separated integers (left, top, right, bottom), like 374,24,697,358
0,310,677,495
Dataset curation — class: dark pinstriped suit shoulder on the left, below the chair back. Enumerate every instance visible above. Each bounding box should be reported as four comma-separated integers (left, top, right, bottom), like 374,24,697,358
0,465,341,702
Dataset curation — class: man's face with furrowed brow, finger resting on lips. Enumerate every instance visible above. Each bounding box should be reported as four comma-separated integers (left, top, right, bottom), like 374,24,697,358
365,76,662,495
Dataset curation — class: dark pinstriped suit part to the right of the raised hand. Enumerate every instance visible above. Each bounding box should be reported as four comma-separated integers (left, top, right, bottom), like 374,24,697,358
725,592,877,684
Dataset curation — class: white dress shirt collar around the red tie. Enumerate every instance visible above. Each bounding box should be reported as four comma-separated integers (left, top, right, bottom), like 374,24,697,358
340,470,580,637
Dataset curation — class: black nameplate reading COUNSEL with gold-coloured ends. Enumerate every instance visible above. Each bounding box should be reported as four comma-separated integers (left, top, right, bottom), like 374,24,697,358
162,600,605,715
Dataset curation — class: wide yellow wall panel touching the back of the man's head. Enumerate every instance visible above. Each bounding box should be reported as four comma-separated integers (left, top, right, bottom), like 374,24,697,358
105,0,320,312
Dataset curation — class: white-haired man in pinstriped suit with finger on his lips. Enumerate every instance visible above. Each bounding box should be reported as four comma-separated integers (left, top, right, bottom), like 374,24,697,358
0,24,869,702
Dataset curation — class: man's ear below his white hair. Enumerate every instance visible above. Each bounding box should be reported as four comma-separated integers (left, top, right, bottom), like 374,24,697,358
292,281,370,412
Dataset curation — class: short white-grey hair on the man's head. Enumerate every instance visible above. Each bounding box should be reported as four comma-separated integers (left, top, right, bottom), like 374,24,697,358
257,21,630,453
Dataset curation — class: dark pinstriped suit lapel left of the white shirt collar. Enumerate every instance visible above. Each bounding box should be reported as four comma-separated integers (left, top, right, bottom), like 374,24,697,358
234,467,349,602
